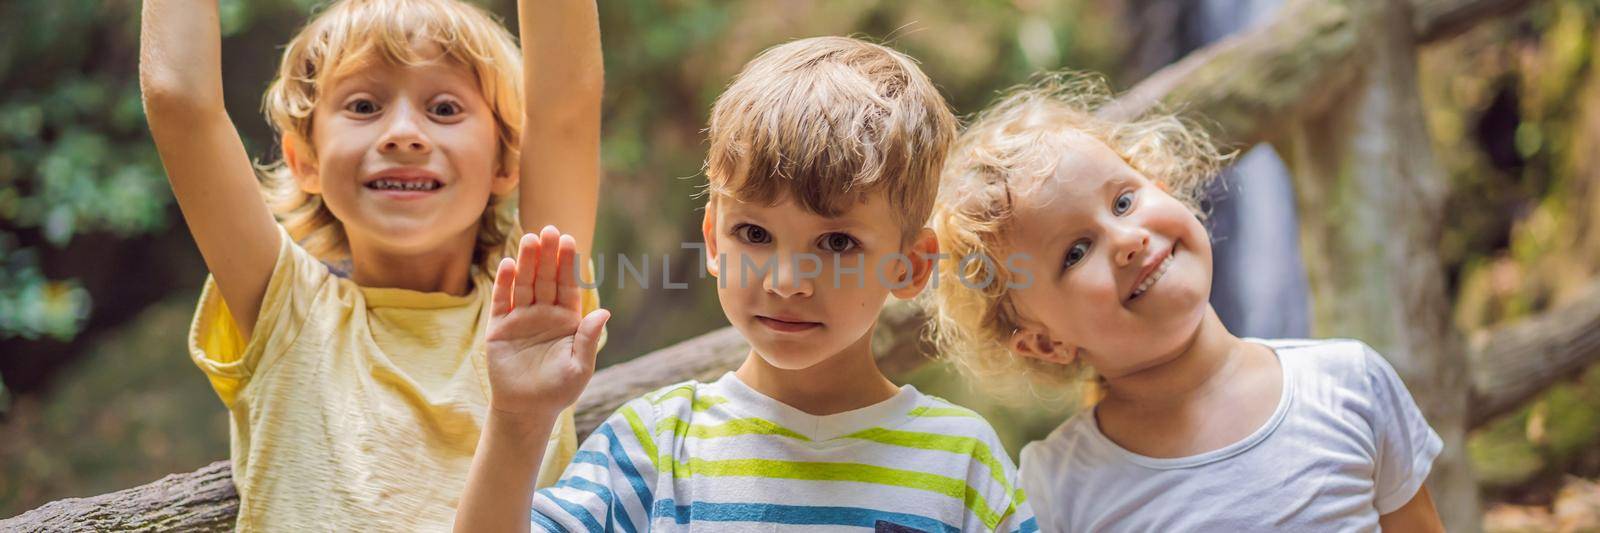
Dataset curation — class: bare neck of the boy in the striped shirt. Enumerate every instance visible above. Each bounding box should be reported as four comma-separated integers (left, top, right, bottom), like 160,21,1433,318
734,323,899,416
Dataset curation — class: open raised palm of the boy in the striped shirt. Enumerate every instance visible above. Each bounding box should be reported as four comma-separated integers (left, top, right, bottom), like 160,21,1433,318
488,226,611,419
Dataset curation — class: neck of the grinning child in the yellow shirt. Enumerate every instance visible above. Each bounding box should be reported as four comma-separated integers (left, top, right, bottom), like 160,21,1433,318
350,226,477,296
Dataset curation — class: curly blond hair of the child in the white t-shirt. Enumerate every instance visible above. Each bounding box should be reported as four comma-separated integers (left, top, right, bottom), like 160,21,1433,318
925,72,1230,403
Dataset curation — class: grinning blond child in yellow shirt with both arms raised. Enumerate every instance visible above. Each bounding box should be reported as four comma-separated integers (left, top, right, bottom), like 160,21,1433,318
139,0,603,531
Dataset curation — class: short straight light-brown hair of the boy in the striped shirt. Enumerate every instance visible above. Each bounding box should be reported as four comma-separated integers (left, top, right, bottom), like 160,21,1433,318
706,37,955,237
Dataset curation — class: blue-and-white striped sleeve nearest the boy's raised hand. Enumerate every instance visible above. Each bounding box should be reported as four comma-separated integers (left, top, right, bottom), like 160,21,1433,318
531,392,658,533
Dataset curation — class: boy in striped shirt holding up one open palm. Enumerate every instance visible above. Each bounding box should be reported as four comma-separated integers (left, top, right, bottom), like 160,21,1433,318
456,37,1037,531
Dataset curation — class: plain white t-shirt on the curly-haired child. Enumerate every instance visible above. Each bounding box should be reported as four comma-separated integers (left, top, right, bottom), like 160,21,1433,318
1021,339,1443,531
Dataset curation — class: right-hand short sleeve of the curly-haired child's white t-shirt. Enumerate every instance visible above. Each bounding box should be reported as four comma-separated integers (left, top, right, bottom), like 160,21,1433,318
1363,346,1443,514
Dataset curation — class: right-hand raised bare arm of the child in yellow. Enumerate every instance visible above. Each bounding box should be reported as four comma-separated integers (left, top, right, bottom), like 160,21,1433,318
517,0,605,254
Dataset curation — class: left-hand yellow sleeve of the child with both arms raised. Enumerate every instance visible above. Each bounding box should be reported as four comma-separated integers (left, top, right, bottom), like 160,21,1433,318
189,226,333,408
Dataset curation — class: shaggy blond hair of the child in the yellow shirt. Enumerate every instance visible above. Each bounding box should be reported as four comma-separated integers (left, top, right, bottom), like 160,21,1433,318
261,0,523,272
